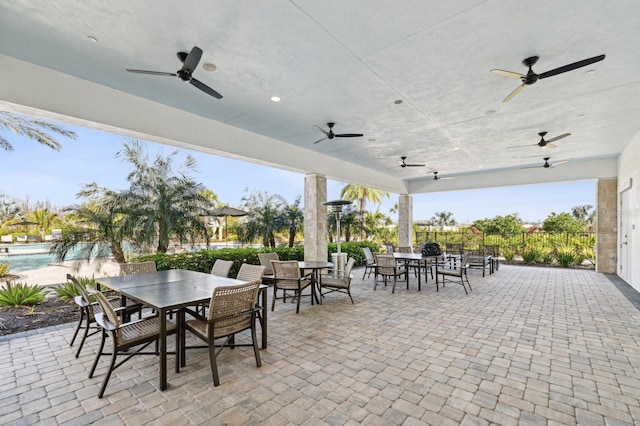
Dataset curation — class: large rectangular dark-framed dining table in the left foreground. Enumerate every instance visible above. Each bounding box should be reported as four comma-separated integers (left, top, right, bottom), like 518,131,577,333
96,269,267,390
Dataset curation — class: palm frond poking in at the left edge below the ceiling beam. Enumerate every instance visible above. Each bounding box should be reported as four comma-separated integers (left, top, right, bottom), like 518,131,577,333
0,111,77,151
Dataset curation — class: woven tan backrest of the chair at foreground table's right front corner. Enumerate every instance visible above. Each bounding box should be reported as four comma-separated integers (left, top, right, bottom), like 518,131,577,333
208,280,261,332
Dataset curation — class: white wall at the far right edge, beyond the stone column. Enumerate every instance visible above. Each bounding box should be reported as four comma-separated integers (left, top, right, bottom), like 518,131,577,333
618,133,640,291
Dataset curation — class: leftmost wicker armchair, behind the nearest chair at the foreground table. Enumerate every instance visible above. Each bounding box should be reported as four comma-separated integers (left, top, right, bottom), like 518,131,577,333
67,274,142,358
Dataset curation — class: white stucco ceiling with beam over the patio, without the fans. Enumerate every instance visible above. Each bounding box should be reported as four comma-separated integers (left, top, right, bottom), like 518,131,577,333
0,0,640,193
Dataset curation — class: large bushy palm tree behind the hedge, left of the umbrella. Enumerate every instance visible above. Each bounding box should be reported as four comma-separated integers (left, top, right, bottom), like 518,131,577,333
111,140,211,253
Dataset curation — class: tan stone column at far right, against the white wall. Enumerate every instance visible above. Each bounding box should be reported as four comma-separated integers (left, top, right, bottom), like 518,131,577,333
596,179,618,274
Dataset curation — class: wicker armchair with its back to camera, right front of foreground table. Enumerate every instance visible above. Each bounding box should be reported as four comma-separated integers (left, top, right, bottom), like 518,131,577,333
180,277,262,386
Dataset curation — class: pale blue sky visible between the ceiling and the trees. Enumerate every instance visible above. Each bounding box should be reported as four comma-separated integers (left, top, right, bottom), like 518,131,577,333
0,121,596,223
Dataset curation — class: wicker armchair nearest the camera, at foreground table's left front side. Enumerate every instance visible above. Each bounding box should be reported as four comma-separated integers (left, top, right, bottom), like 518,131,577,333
89,290,180,398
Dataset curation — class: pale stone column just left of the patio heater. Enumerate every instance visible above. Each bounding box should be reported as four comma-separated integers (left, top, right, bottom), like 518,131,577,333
304,173,329,262
